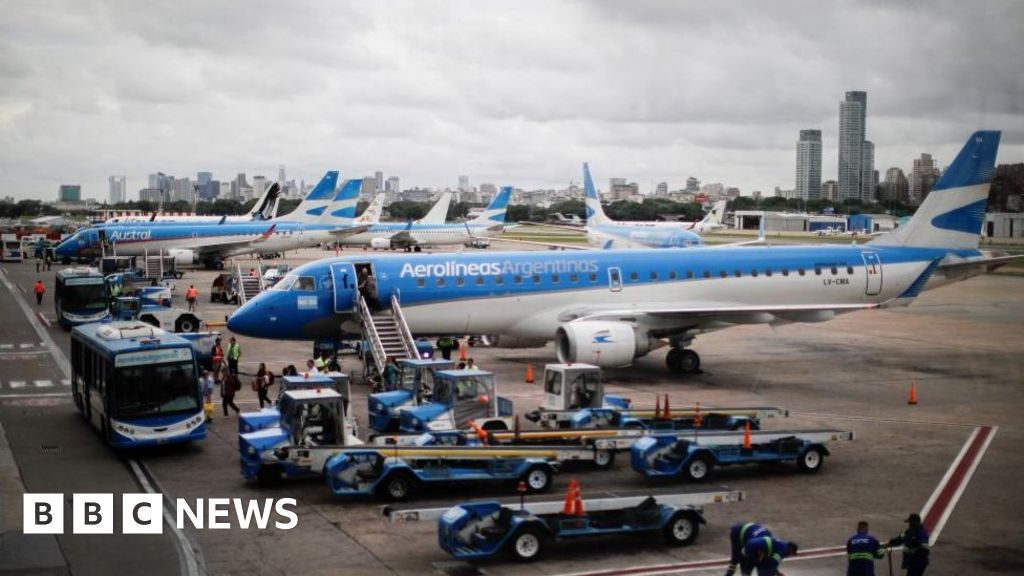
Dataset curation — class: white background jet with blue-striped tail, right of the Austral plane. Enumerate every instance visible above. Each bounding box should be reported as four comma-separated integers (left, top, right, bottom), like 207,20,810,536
341,187,512,252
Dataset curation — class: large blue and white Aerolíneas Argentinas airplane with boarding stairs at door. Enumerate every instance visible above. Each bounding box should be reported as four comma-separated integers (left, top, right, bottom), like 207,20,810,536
227,131,1011,372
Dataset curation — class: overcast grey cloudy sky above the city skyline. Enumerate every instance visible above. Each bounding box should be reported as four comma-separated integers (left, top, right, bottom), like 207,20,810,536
0,0,1024,200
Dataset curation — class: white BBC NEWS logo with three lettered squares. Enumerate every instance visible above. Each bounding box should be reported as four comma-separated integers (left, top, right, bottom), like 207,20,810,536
22,493,299,534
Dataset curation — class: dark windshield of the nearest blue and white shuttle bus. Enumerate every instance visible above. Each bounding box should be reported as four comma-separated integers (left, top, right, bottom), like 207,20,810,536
115,362,200,418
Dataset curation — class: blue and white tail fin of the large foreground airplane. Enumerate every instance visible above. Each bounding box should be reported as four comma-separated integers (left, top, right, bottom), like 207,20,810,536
868,130,1000,249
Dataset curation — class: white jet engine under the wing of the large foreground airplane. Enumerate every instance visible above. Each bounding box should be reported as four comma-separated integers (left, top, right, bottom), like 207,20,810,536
555,321,651,368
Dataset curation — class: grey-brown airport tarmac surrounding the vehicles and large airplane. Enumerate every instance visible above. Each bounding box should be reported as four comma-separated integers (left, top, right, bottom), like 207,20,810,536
0,242,1024,576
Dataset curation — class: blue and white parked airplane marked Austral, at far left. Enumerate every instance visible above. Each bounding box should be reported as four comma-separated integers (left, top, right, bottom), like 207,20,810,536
54,171,370,268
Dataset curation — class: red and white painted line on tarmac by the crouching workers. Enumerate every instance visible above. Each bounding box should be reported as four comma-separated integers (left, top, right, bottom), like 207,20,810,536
558,426,999,576
